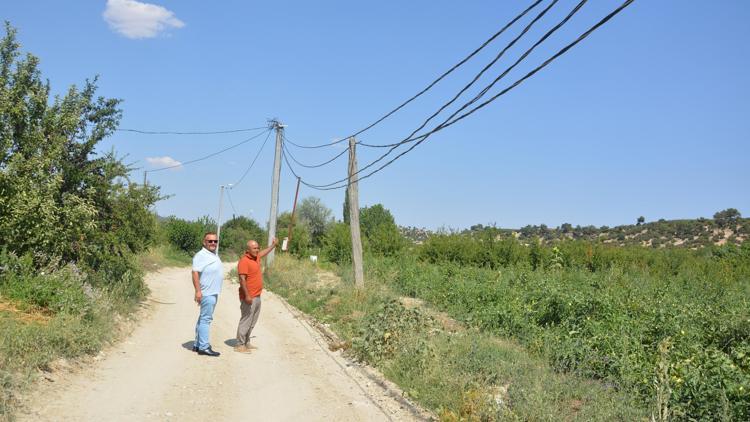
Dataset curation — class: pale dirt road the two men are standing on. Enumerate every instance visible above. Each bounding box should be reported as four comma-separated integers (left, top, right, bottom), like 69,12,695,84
18,265,428,421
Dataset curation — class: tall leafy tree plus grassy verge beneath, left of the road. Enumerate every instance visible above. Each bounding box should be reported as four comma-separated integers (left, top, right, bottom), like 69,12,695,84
0,24,159,416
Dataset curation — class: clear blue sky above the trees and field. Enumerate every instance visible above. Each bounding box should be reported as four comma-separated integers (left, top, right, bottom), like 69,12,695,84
0,0,750,229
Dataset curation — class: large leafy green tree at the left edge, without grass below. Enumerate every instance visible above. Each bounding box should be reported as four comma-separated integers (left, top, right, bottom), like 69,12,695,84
0,23,159,277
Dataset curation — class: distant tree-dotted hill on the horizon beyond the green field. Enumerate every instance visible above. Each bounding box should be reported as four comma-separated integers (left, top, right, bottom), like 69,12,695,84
400,208,750,249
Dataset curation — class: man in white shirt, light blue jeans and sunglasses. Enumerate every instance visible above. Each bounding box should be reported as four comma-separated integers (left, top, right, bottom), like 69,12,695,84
193,232,223,356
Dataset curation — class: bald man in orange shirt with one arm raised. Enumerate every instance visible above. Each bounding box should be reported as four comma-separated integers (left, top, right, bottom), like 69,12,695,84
234,237,279,353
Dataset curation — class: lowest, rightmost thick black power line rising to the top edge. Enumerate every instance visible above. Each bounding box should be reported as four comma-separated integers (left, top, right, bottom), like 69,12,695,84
305,0,634,190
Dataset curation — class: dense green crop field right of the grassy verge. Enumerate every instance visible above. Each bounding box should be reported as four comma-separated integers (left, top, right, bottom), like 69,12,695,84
368,239,750,420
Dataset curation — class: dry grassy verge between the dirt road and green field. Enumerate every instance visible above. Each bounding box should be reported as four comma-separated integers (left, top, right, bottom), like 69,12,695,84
266,256,646,421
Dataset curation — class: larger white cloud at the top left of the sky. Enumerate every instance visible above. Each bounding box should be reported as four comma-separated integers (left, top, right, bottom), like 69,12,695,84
102,0,185,39
